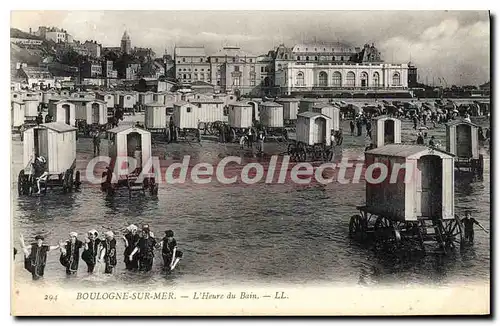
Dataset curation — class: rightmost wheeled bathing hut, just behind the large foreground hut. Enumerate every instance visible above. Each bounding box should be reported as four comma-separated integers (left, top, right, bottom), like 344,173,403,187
446,120,484,175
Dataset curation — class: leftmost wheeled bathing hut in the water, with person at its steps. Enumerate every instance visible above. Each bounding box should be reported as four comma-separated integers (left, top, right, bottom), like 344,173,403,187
18,122,80,195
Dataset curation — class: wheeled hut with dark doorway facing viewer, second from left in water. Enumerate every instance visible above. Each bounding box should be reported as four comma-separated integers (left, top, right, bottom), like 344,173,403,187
101,125,158,196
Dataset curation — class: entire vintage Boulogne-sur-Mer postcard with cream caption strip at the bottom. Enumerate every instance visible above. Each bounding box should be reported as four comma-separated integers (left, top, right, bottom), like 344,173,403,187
10,11,492,316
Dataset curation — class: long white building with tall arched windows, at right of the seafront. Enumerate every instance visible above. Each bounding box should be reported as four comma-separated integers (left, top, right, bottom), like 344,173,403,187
273,43,408,95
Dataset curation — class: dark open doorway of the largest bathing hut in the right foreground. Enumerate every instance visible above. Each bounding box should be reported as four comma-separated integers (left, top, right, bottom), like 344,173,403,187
417,155,443,218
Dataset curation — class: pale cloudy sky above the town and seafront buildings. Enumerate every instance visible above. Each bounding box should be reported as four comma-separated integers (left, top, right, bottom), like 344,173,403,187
11,11,490,86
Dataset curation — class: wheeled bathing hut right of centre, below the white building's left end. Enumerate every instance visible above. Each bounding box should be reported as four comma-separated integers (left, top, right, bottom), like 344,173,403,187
288,111,333,162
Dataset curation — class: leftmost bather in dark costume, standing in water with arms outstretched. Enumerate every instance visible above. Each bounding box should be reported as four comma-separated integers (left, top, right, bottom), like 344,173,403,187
19,234,60,280
